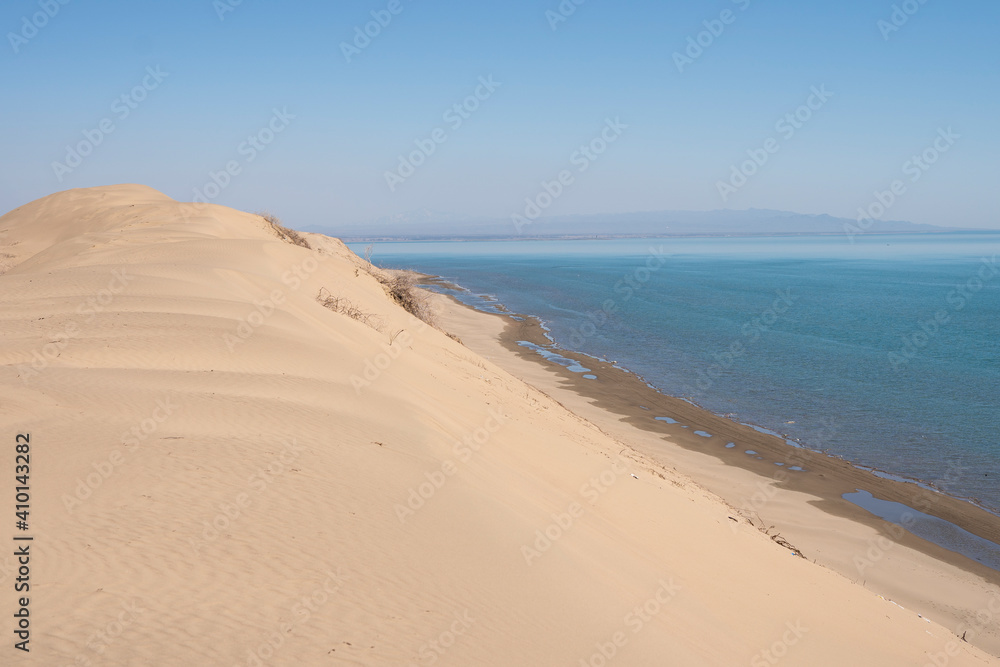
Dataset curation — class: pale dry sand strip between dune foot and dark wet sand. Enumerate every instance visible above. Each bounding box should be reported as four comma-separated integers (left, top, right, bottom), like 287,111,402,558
431,294,1000,656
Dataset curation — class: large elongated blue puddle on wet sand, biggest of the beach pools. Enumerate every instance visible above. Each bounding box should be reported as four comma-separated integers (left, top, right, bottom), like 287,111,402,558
842,489,1000,571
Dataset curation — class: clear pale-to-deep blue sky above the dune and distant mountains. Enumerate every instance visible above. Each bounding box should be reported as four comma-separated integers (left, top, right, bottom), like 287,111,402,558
0,0,1000,227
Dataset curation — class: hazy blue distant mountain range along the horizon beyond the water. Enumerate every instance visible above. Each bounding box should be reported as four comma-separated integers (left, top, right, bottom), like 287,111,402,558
304,209,958,241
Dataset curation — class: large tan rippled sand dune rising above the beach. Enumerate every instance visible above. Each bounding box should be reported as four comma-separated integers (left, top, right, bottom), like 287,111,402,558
0,186,1000,666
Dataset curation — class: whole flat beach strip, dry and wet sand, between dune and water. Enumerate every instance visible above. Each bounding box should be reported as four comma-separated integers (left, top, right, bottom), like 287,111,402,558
412,272,1000,655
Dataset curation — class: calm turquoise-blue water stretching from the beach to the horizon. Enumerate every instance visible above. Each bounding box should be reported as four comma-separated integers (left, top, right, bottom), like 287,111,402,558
354,233,1000,510
